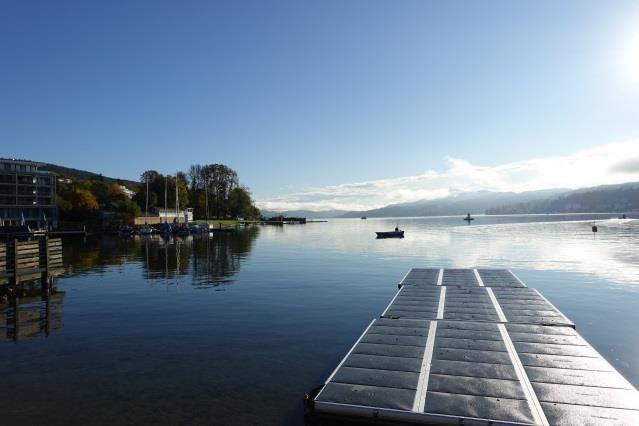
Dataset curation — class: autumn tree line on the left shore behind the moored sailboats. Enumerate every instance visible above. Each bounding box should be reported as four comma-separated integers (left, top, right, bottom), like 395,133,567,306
56,164,261,230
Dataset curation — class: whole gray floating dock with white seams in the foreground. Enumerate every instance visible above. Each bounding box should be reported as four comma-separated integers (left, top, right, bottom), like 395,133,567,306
307,268,639,425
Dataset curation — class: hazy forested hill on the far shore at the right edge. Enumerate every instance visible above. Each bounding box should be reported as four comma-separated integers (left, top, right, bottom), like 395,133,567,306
486,182,639,214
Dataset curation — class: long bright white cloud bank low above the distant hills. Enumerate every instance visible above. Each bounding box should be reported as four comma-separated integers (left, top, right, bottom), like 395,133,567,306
258,141,639,210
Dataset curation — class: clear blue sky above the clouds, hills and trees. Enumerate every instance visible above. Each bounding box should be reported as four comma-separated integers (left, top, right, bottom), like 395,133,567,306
0,0,639,208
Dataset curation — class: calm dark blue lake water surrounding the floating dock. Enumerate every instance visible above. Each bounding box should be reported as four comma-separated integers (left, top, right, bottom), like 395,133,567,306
0,215,639,425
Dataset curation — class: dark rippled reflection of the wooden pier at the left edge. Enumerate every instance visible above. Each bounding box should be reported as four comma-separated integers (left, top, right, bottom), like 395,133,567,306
0,278,64,343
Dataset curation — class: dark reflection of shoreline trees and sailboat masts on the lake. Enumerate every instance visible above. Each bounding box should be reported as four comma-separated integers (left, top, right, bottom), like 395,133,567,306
63,227,259,287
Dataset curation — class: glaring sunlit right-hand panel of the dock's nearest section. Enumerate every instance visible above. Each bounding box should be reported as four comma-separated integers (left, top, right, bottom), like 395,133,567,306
506,324,639,425
